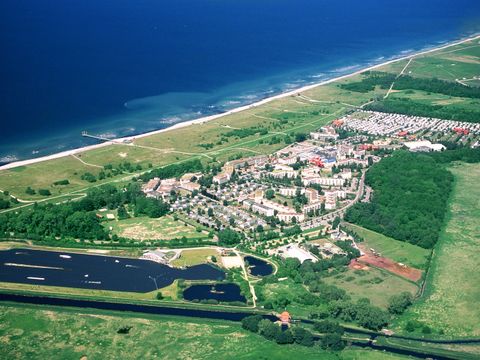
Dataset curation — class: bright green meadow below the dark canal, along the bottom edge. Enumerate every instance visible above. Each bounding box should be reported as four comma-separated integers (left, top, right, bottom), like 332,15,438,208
0,305,410,360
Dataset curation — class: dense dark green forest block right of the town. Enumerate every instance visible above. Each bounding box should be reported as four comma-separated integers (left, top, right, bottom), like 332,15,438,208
345,151,453,248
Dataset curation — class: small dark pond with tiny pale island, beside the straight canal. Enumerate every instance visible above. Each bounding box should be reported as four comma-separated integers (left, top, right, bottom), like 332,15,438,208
183,284,247,302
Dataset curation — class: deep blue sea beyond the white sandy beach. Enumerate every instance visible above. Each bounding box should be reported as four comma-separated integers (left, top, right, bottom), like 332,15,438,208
0,0,480,162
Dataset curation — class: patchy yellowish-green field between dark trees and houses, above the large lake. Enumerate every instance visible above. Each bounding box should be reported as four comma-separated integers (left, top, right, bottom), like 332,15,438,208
104,216,208,240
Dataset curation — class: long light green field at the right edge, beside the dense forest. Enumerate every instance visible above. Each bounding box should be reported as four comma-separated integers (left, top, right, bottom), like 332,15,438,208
399,164,480,337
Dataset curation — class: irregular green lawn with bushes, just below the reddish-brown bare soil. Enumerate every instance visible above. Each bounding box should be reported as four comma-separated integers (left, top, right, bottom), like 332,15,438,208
324,267,418,309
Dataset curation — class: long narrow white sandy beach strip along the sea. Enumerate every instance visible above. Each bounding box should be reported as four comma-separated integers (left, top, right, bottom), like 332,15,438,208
0,34,480,171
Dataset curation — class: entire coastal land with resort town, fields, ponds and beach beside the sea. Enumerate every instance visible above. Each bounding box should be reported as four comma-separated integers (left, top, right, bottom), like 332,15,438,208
0,22,480,359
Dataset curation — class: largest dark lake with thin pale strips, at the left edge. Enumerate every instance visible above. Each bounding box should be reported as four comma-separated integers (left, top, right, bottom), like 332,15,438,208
0,249,225,292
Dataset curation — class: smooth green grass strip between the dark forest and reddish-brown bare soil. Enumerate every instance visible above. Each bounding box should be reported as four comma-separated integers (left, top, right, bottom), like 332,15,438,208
346,224,430,269
